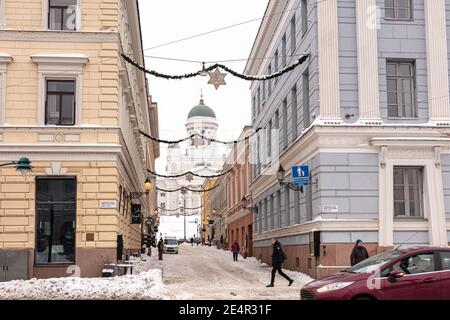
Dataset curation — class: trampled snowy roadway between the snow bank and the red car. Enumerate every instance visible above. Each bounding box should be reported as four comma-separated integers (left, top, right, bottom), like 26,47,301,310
156,244,312,300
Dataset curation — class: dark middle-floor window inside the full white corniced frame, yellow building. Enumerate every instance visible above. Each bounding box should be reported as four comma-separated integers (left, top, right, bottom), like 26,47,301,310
45,80,75,125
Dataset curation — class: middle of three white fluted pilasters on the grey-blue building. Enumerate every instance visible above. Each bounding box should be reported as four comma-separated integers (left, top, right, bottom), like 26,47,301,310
356,0,380,123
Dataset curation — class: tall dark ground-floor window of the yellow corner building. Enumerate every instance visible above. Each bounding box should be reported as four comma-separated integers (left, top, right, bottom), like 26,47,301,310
35,178,77,264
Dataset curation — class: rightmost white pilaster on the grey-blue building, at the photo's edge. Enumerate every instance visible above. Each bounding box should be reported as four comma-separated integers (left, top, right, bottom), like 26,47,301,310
425,0,450,121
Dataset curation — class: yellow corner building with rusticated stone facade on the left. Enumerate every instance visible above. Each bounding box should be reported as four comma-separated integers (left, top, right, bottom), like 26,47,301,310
0,0,159,281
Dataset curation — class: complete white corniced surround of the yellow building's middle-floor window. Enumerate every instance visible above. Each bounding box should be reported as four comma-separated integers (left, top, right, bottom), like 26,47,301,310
31,54,89,127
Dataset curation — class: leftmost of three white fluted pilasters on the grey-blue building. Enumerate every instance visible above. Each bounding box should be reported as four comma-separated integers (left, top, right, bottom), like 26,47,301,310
317,1,341,122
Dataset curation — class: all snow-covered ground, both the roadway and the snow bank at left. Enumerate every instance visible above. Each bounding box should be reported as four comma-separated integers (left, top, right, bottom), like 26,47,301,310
0,244,312,300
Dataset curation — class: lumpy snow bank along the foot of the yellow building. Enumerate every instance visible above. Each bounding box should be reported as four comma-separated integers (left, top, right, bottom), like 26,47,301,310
0,259,167,300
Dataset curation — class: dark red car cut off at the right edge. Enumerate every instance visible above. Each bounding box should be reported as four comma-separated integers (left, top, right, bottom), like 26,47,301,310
300,247,450,300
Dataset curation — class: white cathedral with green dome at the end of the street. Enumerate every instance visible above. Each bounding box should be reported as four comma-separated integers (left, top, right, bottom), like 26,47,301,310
157,97,227,239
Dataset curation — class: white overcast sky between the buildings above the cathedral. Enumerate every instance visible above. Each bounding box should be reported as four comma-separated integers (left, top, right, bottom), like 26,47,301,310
140,0,268,171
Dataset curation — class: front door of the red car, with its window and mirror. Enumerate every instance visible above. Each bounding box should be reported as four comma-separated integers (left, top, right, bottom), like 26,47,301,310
382,252,441,300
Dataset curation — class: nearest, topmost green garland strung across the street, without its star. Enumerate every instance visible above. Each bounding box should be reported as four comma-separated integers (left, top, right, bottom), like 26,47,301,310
121,53,309,81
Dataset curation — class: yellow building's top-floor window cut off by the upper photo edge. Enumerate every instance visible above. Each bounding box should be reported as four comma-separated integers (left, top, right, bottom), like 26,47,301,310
48,0,77,31
